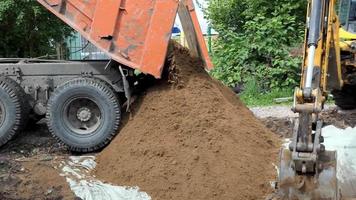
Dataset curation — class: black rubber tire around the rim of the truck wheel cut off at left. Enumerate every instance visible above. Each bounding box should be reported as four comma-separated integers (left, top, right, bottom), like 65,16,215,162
0,76,29,146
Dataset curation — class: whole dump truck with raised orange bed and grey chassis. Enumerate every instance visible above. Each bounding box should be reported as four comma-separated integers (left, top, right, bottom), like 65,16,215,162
0,0,212,152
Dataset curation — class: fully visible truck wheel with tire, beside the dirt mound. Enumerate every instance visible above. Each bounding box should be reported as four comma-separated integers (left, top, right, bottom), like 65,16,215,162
46,78,121,152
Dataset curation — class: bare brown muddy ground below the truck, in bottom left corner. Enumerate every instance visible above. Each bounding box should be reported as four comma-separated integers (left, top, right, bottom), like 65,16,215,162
0,123,75,200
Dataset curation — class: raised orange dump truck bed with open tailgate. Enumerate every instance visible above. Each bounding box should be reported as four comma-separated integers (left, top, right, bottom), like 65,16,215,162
37,0,212,78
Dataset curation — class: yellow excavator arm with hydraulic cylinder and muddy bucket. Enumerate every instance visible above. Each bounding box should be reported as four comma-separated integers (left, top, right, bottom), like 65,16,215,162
279,0,343,200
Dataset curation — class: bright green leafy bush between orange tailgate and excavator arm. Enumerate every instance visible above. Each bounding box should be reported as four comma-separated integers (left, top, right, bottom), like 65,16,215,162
207,0,307,90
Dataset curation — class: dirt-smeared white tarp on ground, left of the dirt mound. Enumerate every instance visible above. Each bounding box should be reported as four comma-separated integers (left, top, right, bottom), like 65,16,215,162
59,156,151,200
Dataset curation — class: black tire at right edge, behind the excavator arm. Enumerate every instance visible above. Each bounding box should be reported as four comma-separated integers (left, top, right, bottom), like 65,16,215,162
332,85,356,110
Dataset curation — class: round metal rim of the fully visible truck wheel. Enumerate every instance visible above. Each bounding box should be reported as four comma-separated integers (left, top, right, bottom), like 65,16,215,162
62,97,102,135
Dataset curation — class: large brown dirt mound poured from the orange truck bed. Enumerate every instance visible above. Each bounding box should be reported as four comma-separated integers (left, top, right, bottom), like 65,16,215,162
96,45,278,200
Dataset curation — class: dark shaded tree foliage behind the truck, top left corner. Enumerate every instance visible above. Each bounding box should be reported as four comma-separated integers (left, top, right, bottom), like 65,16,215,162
0,0,72,57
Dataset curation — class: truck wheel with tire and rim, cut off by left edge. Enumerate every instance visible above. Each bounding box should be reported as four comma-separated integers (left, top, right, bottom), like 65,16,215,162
0,77,29,146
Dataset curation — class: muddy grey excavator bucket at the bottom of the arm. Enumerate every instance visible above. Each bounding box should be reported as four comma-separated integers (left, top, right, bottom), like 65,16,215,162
278,149,340,200
